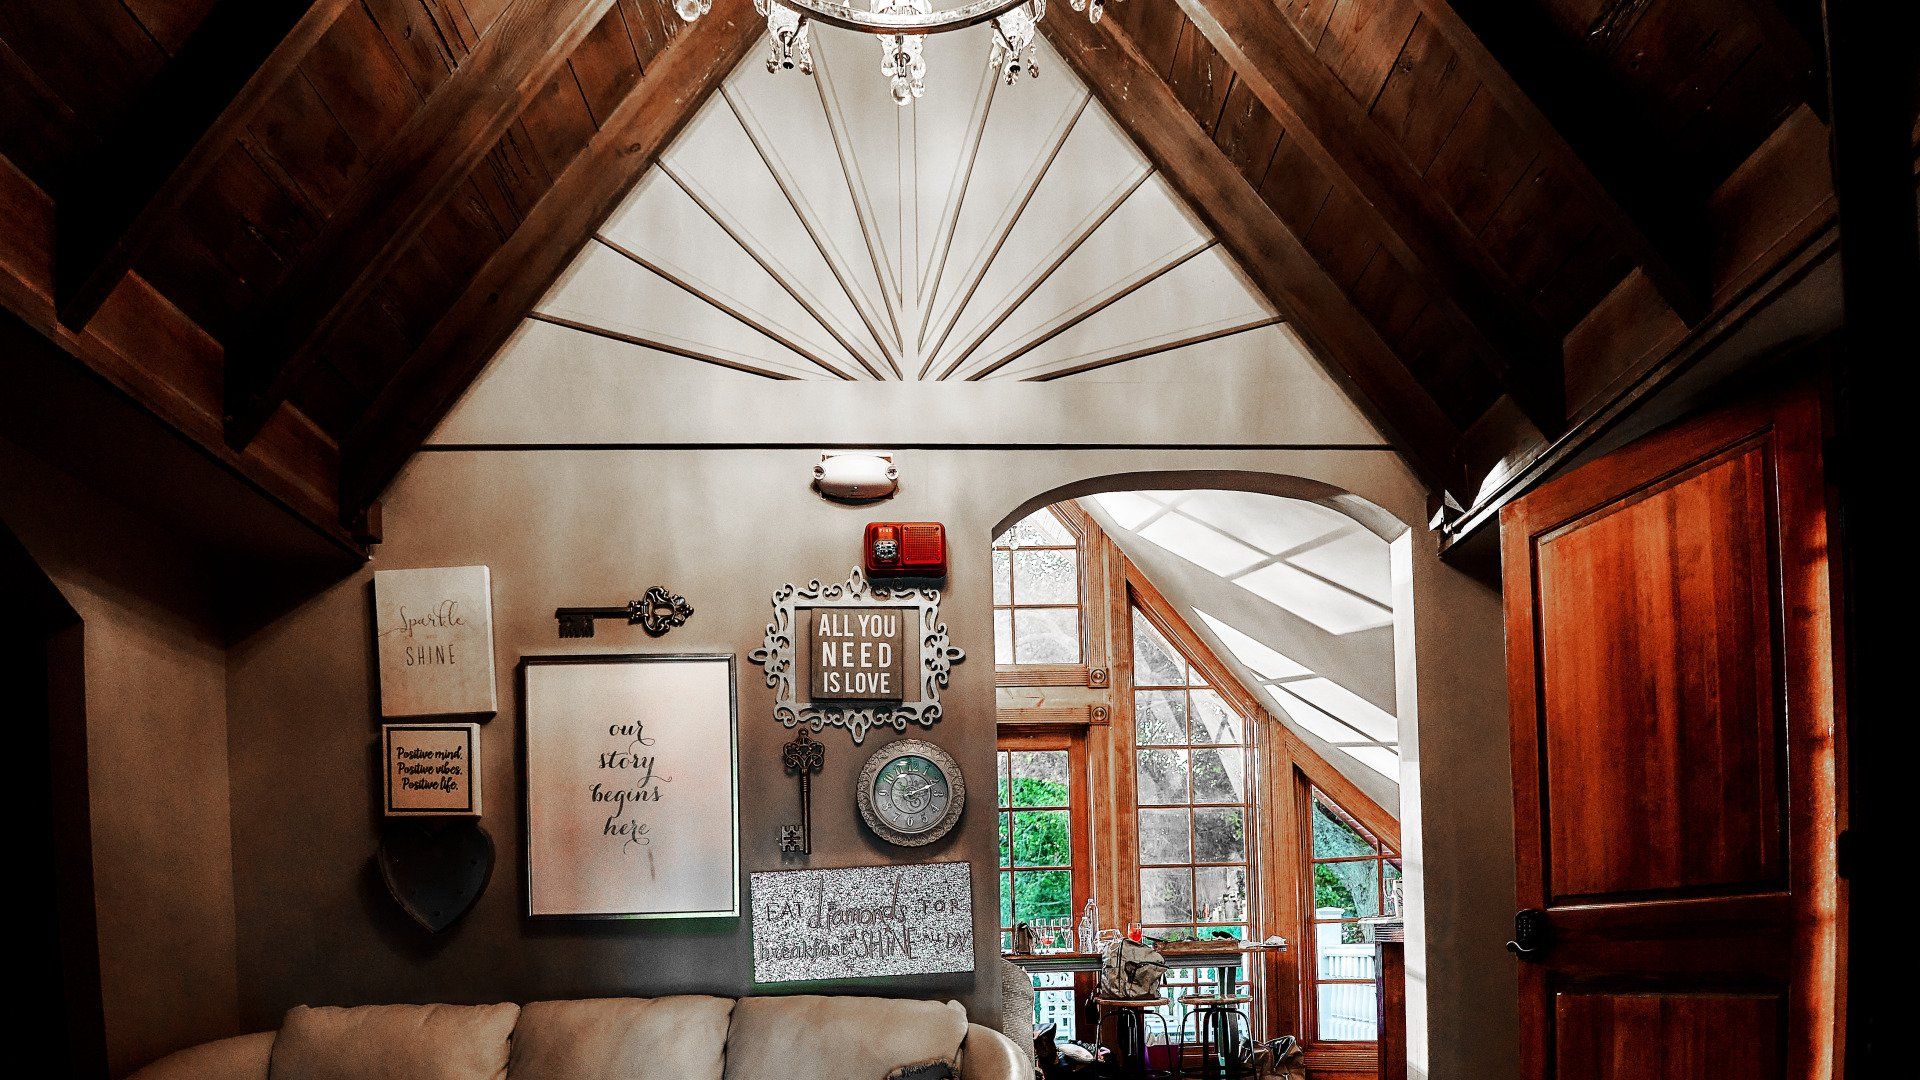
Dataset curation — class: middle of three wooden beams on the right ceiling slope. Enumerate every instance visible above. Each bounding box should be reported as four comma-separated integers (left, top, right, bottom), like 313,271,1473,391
1179,0,1567,434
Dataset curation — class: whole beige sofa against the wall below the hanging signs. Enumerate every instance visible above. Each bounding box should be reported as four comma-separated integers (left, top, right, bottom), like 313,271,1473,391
132,995,1031,1080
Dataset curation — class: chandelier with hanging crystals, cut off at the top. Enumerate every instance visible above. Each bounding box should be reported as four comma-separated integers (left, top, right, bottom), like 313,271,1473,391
674,0,1106,106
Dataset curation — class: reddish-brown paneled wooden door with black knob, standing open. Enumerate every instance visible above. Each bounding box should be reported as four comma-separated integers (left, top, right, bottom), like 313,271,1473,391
1501,386,1843,1080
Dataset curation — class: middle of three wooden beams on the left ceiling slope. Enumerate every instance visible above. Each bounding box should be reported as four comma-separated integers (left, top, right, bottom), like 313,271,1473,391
227,0,614,448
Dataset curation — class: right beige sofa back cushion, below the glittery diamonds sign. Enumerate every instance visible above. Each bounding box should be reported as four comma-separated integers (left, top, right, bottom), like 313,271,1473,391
726,995,966,1080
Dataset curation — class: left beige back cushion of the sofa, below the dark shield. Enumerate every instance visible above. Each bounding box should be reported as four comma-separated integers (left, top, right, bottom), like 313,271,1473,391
267,1003,520,1080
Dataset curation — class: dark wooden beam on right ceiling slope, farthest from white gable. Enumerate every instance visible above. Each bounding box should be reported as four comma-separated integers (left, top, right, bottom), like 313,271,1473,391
1443,0,1709,323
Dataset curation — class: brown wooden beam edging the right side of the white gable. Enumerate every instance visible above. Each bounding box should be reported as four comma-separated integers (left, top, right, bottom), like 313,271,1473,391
1041,17,1459,490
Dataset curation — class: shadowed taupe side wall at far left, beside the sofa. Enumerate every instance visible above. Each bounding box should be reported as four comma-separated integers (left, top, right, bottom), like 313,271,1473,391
0,432,240,1076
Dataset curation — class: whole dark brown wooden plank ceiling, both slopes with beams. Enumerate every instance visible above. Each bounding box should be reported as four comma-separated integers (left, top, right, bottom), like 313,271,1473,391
0,0,1858,553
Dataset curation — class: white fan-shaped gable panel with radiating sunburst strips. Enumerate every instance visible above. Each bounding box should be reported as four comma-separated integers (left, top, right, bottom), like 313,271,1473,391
534,31,1279,380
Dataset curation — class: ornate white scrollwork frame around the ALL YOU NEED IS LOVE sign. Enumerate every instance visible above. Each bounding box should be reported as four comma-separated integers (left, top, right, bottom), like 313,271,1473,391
747,567,966,746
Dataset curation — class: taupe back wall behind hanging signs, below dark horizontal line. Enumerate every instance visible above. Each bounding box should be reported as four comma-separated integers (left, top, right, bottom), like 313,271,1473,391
228,440,1428,1026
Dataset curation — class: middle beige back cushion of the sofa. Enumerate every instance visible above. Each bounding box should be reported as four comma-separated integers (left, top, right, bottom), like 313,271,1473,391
507,997,733,1080
